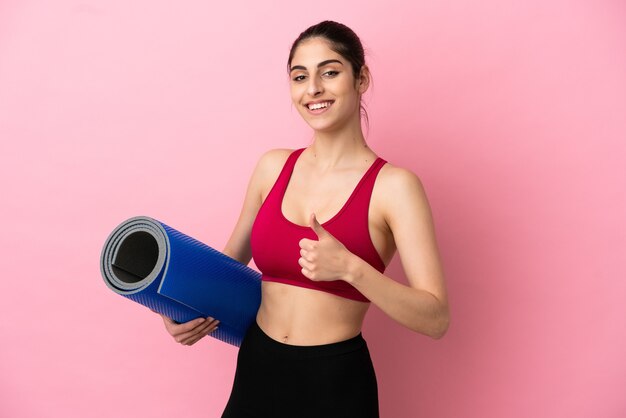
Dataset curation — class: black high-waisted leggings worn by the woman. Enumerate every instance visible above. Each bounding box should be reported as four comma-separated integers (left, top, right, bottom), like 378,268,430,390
222,321,379,418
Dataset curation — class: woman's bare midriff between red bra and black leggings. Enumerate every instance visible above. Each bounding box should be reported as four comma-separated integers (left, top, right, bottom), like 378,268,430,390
256,281,370,345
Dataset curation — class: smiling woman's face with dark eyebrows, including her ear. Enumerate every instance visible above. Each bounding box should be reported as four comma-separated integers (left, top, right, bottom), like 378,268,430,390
289,38,367,132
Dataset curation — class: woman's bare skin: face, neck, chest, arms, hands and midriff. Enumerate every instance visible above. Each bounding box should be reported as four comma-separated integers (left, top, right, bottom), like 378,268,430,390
158,38,449,345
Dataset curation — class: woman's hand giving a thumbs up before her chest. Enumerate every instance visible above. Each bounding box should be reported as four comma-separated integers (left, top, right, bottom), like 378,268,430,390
298,213,352,281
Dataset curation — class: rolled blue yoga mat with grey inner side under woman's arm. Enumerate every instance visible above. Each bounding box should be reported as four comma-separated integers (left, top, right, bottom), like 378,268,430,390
100,216,261,346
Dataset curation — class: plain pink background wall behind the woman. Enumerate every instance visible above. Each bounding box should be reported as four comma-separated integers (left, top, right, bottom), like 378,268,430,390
0,0,626,418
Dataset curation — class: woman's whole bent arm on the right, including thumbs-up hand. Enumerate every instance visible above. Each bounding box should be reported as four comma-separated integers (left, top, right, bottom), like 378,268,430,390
300,167,450,338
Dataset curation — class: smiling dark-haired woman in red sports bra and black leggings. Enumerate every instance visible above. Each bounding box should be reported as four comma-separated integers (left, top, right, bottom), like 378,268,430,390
158,21,449,418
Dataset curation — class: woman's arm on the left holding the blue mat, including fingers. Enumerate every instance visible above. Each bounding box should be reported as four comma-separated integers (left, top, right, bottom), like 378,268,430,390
161,149,291,345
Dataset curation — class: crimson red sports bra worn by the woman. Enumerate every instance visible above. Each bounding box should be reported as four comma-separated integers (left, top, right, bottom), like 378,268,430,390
250,148,386,302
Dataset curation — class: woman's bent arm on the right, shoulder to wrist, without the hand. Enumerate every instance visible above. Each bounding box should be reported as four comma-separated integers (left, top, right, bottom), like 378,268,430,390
344,167,450,338
